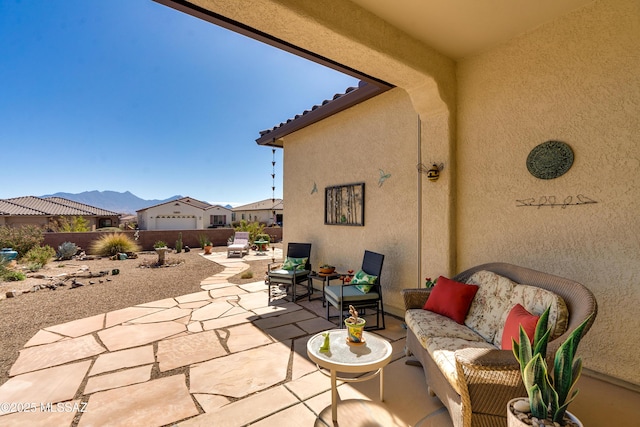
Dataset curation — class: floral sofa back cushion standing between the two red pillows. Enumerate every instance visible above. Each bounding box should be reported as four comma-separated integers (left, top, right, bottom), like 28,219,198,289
464,270,517,345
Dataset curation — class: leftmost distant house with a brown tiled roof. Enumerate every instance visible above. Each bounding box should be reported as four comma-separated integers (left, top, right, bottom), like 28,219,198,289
0,196,120,230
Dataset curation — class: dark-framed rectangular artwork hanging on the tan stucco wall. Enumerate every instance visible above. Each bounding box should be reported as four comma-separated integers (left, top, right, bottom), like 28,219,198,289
324,182,364,226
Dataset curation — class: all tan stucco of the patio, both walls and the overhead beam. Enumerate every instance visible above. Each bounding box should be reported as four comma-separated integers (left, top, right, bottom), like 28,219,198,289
180,0,640,385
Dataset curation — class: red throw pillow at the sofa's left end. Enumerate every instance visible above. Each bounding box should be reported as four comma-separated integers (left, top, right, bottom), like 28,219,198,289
423,276,478,325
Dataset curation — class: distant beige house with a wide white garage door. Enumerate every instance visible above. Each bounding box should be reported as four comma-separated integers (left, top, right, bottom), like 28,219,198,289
136,197,231,230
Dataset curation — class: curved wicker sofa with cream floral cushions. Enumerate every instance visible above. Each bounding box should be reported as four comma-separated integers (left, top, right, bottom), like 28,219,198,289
403,263,597,427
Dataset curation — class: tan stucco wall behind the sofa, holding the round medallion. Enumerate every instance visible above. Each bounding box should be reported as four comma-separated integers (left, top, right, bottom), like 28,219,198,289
457,0,640,384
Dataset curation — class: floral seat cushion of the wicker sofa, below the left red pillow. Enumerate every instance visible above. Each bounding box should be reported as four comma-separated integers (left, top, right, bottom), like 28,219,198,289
404,308,484,349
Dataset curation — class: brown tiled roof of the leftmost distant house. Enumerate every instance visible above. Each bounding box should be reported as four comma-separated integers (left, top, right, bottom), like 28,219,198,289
0,196,119,216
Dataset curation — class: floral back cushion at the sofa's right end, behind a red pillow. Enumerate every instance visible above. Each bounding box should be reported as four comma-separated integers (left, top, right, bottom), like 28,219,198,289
493,285,569,346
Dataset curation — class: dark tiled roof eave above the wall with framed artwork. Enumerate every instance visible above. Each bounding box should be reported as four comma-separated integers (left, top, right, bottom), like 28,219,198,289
256,81,392,147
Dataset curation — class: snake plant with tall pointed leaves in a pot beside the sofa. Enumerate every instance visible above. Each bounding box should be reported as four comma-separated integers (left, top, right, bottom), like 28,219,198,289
507,308,593,427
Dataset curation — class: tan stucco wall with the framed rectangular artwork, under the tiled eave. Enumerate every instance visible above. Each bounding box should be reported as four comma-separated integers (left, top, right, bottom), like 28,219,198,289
283,89,418,314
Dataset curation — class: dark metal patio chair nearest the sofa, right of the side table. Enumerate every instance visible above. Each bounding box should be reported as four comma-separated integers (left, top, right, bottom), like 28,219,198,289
324,250,385,330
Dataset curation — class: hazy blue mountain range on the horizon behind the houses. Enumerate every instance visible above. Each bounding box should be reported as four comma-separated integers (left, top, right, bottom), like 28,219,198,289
40,190,183,215
